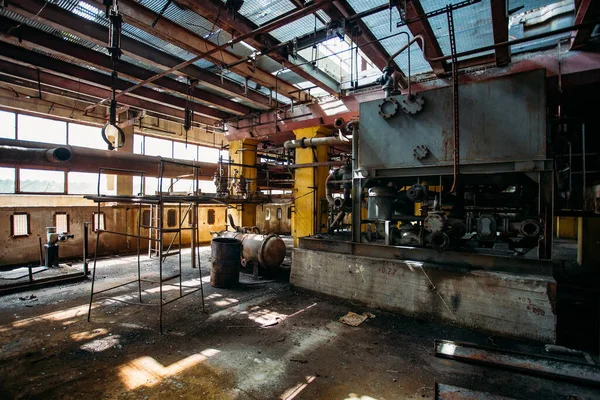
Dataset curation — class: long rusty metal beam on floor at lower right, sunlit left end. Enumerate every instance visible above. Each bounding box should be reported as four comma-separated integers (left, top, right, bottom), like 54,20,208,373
434,339,600,386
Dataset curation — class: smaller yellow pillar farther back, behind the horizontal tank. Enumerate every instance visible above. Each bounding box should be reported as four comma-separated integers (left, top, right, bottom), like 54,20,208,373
229,139,258,226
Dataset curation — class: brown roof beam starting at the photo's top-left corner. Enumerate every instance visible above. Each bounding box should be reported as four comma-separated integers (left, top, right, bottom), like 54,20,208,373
6,0,272,109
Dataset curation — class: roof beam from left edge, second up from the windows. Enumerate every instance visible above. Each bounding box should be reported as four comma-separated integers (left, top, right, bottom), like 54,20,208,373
0,17,252,115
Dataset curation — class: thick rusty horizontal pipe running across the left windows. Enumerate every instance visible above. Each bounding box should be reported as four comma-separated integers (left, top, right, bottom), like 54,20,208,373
0,139,218,180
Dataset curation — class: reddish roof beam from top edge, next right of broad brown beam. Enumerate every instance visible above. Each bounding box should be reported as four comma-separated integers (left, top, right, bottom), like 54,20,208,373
177,0,339,96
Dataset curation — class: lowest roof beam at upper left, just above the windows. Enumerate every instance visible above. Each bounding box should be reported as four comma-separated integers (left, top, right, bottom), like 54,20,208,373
0,53,216,125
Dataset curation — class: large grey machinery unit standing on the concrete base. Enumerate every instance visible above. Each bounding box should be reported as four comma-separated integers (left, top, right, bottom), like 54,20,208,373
328,70,553,258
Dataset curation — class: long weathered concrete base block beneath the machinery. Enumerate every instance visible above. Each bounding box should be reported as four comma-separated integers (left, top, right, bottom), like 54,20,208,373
290,248,556,343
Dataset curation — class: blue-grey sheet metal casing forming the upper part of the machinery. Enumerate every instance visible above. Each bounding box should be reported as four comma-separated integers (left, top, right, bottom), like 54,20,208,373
359,70,547,169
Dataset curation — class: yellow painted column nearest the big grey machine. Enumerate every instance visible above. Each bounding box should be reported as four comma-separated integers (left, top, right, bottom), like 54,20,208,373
292,126,331,246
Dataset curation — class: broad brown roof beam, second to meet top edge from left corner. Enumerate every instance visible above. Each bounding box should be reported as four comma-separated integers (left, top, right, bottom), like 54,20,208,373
83,0,301,100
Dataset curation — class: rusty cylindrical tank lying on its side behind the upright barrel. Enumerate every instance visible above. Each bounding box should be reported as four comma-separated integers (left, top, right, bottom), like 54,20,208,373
213,231,286,269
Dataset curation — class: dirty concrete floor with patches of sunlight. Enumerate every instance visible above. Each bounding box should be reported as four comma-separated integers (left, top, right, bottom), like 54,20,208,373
0,247,600,400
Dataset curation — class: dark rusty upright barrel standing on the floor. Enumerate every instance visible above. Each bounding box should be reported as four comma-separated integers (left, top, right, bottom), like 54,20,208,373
210,237,242,288
